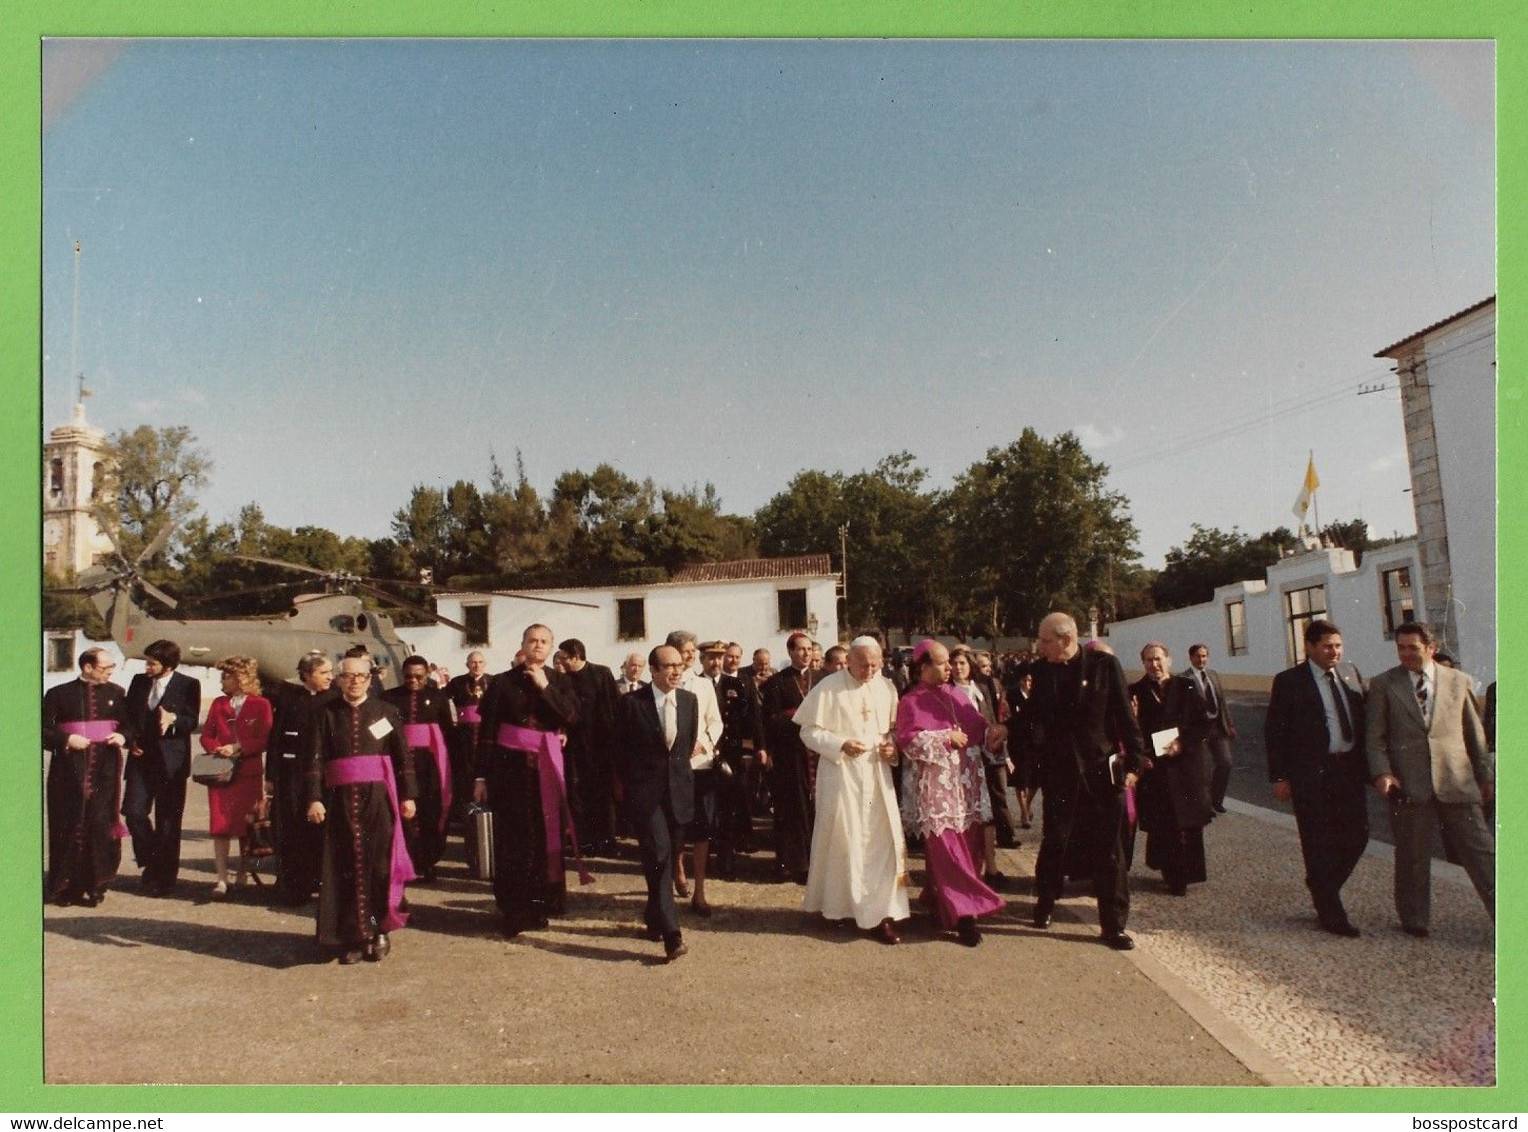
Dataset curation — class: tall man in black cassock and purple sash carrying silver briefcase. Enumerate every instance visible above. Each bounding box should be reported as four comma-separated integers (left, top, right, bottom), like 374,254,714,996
472,625,578,936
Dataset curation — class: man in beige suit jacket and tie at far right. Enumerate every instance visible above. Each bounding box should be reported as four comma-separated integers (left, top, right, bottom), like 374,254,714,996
1368,625,1496,938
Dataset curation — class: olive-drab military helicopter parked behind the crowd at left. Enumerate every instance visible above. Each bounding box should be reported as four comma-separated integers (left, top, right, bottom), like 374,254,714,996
55,526,596,687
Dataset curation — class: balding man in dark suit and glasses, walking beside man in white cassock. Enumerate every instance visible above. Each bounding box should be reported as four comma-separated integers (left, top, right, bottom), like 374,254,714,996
619,645,700,962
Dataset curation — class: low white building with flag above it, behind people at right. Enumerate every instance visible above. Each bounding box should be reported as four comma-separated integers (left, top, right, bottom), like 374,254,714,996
1106,539,1421,692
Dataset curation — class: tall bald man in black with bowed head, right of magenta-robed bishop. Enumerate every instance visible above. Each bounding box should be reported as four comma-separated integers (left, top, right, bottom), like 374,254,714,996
1028,613,1141,952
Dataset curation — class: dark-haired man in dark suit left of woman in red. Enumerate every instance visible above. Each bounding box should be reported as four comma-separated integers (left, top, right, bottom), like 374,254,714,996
122,640,202,897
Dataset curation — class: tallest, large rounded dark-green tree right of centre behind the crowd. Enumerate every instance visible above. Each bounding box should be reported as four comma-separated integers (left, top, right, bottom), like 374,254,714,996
944,428,1138,634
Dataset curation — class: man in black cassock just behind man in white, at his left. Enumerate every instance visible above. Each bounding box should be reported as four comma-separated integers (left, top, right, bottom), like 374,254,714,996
759,632,814,885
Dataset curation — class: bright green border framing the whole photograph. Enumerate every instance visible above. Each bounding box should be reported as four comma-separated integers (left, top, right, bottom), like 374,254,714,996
0,0,1528,1114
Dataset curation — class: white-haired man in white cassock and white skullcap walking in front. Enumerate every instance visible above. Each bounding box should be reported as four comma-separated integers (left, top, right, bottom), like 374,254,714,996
795,637,911,944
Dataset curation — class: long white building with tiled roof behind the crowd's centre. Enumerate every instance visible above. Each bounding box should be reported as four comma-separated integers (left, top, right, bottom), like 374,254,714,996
399,555,839,672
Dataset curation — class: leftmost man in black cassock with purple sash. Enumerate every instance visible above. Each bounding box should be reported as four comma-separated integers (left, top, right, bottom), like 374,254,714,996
43,648,133,907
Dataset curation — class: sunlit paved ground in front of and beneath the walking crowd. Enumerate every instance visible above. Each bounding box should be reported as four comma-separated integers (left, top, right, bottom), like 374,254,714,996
44,721,1494,1085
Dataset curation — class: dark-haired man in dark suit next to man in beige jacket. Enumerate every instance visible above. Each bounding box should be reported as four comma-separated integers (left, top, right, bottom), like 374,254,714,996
1264,620,1369,938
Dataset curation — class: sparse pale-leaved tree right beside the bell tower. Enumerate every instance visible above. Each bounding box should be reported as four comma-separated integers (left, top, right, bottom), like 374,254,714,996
95,425,212,565
